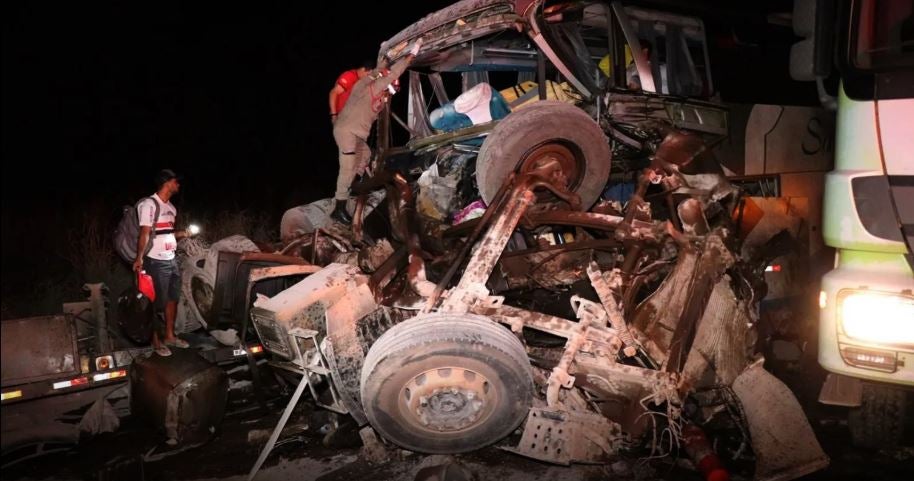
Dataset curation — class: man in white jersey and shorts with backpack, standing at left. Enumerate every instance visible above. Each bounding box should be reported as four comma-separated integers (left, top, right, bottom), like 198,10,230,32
133,169,191,356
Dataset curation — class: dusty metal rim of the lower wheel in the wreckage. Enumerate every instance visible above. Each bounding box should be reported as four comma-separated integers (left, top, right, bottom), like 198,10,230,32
400,367,498,433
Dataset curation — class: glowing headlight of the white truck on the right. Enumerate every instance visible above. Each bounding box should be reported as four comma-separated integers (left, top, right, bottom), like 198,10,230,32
837,291,914,346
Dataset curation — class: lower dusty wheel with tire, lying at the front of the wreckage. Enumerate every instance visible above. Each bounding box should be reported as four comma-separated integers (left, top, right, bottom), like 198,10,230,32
361,314,533,454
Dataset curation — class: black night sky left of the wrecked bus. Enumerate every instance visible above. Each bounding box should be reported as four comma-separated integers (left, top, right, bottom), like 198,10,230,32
0,0,450,292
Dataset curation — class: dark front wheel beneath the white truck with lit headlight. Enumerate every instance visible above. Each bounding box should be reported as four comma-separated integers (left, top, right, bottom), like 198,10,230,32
847,383,905,449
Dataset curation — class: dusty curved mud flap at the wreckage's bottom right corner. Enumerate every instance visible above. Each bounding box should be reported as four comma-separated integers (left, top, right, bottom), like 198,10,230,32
733,361,828,481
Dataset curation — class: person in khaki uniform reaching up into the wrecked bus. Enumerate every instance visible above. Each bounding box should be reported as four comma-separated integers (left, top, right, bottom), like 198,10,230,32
330,38,422,224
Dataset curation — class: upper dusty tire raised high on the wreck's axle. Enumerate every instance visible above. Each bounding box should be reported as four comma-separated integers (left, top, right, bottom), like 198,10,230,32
476,100,612,210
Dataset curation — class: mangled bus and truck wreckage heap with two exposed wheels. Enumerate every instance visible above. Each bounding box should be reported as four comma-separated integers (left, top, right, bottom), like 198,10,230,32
235,0,828,480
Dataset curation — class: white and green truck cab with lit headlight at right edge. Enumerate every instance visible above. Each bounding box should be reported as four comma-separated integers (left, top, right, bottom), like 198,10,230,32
791,0,914,448
